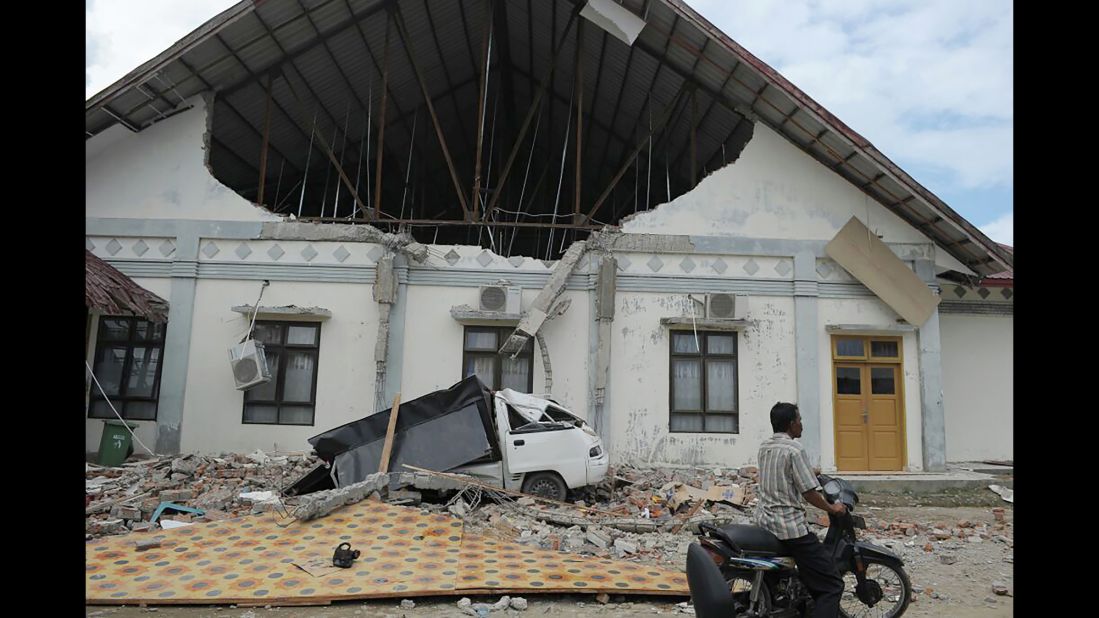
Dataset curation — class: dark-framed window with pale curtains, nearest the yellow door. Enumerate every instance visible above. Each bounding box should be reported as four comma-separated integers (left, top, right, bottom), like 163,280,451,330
670,331,740,433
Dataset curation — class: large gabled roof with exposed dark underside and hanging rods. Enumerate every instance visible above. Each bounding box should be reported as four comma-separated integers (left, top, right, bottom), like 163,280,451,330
85,0,1012,276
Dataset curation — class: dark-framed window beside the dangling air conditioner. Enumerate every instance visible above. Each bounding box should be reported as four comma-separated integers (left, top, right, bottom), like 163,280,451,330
244,321,321,424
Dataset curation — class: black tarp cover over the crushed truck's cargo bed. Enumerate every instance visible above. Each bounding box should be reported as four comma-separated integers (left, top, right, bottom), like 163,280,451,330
309,375,501,486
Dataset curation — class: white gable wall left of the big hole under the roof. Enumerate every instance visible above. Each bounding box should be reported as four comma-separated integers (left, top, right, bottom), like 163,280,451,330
85,97,280,221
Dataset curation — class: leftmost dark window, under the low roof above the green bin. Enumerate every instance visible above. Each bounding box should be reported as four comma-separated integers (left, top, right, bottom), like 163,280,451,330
88,316,165,420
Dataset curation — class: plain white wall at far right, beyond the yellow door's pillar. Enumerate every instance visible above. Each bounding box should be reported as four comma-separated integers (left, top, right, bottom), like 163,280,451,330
940,313,1014,462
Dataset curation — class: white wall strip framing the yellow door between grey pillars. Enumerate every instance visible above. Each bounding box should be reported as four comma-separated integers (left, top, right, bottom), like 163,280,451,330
817,298,923,472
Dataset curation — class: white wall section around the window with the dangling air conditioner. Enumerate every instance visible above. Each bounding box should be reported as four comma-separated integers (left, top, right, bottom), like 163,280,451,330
173,279,378,453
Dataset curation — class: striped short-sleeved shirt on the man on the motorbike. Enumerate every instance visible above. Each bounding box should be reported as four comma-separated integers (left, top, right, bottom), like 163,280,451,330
755,432,821,541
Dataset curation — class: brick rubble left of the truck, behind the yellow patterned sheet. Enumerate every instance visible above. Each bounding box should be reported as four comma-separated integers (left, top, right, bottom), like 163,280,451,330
85,450,318,539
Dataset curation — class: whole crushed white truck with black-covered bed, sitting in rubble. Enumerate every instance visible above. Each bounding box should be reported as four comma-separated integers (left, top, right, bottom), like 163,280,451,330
284,375,609,500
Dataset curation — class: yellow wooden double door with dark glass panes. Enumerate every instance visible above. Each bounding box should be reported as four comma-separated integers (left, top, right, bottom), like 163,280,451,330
832,336,904,472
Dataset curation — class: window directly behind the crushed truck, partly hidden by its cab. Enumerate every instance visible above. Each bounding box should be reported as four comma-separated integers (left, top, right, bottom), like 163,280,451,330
462,327,534,393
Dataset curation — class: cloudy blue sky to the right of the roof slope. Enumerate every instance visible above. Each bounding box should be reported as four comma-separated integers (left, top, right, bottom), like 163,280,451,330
691,0,1014,190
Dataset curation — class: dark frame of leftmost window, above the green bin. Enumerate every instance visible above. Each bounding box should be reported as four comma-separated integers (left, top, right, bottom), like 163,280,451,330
88,316,168,421
